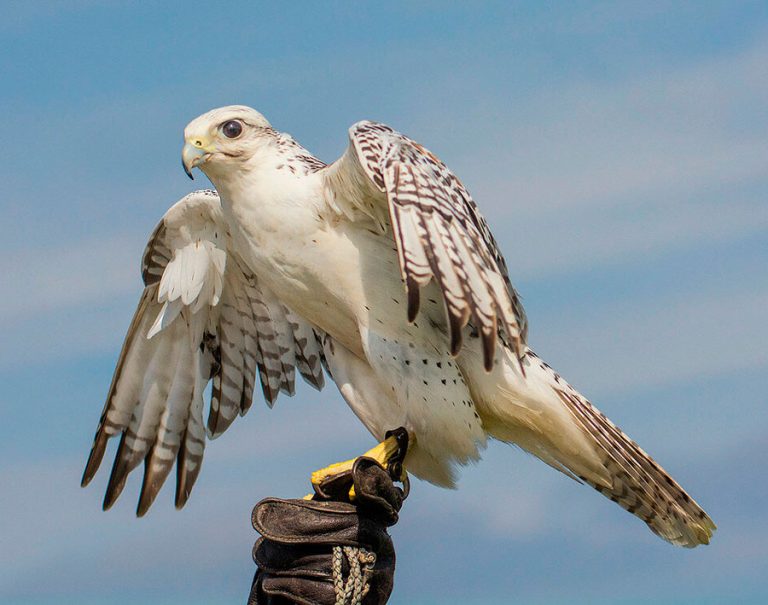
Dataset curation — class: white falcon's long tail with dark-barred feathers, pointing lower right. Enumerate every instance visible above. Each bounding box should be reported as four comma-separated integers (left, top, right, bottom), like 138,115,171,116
483,350,716,548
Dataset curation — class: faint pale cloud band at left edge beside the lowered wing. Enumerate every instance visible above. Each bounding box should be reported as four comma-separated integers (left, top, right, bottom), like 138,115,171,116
0,233,144,368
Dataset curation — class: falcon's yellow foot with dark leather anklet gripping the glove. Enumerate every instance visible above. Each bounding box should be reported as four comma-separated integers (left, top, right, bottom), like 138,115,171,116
312,427,409,500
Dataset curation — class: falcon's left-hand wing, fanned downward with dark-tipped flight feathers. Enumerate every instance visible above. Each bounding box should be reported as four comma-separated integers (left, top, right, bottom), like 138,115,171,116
82,191,324,516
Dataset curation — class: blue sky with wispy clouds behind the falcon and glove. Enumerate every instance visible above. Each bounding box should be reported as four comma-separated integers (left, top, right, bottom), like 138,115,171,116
0,0,768,605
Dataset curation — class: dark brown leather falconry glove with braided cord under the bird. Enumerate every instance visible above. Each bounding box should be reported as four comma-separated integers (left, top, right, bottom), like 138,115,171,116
248,458,404,605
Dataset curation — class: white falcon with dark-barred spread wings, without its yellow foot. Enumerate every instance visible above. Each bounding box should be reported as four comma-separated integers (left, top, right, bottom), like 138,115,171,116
83,106,715,547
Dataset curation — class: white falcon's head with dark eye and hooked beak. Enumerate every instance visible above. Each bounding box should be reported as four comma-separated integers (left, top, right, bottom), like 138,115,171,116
181,105,274,178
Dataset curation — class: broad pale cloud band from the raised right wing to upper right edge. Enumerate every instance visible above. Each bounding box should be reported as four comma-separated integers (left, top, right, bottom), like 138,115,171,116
433,41,768,286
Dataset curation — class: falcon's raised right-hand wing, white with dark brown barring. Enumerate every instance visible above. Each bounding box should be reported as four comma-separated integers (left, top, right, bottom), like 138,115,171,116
326,121,527,370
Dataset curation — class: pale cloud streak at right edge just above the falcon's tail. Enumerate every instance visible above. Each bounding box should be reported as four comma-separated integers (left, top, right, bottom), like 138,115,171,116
534,286,768,393
